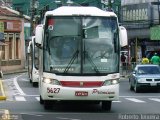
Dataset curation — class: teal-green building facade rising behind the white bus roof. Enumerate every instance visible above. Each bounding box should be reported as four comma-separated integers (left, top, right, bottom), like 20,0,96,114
10,0,121,16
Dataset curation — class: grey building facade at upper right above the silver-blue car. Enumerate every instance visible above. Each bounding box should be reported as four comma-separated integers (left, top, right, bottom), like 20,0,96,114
121,0,160,62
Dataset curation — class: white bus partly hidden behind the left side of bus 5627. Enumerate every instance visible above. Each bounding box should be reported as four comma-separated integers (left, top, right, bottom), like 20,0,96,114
27,36,39,87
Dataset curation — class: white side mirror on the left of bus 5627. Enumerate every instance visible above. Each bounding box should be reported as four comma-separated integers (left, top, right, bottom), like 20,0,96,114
35,24,43,46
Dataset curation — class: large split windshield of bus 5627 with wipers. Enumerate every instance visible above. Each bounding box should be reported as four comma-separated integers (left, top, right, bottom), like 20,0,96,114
43,16,119,75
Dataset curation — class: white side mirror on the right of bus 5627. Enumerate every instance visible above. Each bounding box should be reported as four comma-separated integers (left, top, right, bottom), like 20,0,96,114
119,26,128,47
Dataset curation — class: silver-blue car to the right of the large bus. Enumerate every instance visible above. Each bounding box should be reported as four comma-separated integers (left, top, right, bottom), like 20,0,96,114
129,64,160,93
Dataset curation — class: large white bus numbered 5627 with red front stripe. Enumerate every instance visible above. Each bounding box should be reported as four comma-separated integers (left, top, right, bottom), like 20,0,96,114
36,6,126,110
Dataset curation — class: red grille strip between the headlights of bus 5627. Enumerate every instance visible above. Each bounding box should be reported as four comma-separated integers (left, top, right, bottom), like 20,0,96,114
61,81,103,87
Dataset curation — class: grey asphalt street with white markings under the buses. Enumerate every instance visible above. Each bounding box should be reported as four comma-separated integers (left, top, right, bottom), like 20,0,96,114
0,73,160,120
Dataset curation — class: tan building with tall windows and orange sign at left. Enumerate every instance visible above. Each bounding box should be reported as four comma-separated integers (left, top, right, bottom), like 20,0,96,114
0,7,29,71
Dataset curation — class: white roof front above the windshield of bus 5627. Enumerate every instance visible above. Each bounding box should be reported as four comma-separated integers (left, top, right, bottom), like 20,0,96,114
45,6,117,17
